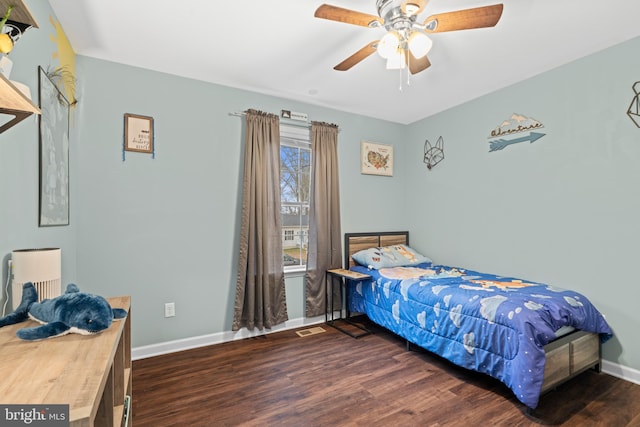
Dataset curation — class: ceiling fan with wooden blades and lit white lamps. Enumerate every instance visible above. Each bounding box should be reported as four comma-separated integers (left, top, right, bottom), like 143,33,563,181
314,0,503,74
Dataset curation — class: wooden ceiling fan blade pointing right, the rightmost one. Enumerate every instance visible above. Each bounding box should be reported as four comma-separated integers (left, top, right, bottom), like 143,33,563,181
424,4,503,33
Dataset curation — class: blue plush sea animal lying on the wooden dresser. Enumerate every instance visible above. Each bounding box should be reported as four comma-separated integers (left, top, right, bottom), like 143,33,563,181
0,282,127,341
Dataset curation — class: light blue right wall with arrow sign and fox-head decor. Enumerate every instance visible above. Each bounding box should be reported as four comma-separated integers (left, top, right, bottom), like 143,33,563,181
402,39,640,369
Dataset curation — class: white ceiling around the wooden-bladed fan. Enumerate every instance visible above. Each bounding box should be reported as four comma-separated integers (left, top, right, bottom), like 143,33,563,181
49,0,640,124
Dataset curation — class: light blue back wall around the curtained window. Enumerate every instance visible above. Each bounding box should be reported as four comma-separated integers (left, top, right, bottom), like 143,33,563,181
74,56,405,346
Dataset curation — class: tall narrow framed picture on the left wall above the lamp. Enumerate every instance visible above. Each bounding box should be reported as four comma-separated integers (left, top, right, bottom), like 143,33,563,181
38,67,69,227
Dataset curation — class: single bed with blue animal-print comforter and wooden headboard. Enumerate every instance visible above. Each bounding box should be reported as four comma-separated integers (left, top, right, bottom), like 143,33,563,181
345,232,612,410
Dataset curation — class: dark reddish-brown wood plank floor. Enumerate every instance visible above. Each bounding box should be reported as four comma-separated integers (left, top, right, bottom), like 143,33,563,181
133,325,640,427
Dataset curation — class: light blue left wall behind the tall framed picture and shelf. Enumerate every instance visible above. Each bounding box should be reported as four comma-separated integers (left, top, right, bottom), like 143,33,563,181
0,1,79,308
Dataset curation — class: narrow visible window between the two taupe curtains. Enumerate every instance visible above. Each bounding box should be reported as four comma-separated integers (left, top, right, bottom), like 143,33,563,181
280,125,311,272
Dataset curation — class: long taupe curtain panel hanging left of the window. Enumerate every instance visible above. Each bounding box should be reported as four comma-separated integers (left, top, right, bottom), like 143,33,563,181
232,110,288,331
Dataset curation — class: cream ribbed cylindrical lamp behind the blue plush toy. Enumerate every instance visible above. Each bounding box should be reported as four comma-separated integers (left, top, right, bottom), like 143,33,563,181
11,248,62,310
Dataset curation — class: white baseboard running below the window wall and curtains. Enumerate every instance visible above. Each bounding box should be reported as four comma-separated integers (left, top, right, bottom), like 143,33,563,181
131,315,324,360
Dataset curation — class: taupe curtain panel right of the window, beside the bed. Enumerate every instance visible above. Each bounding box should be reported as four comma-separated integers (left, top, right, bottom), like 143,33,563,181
305,122,342,317
